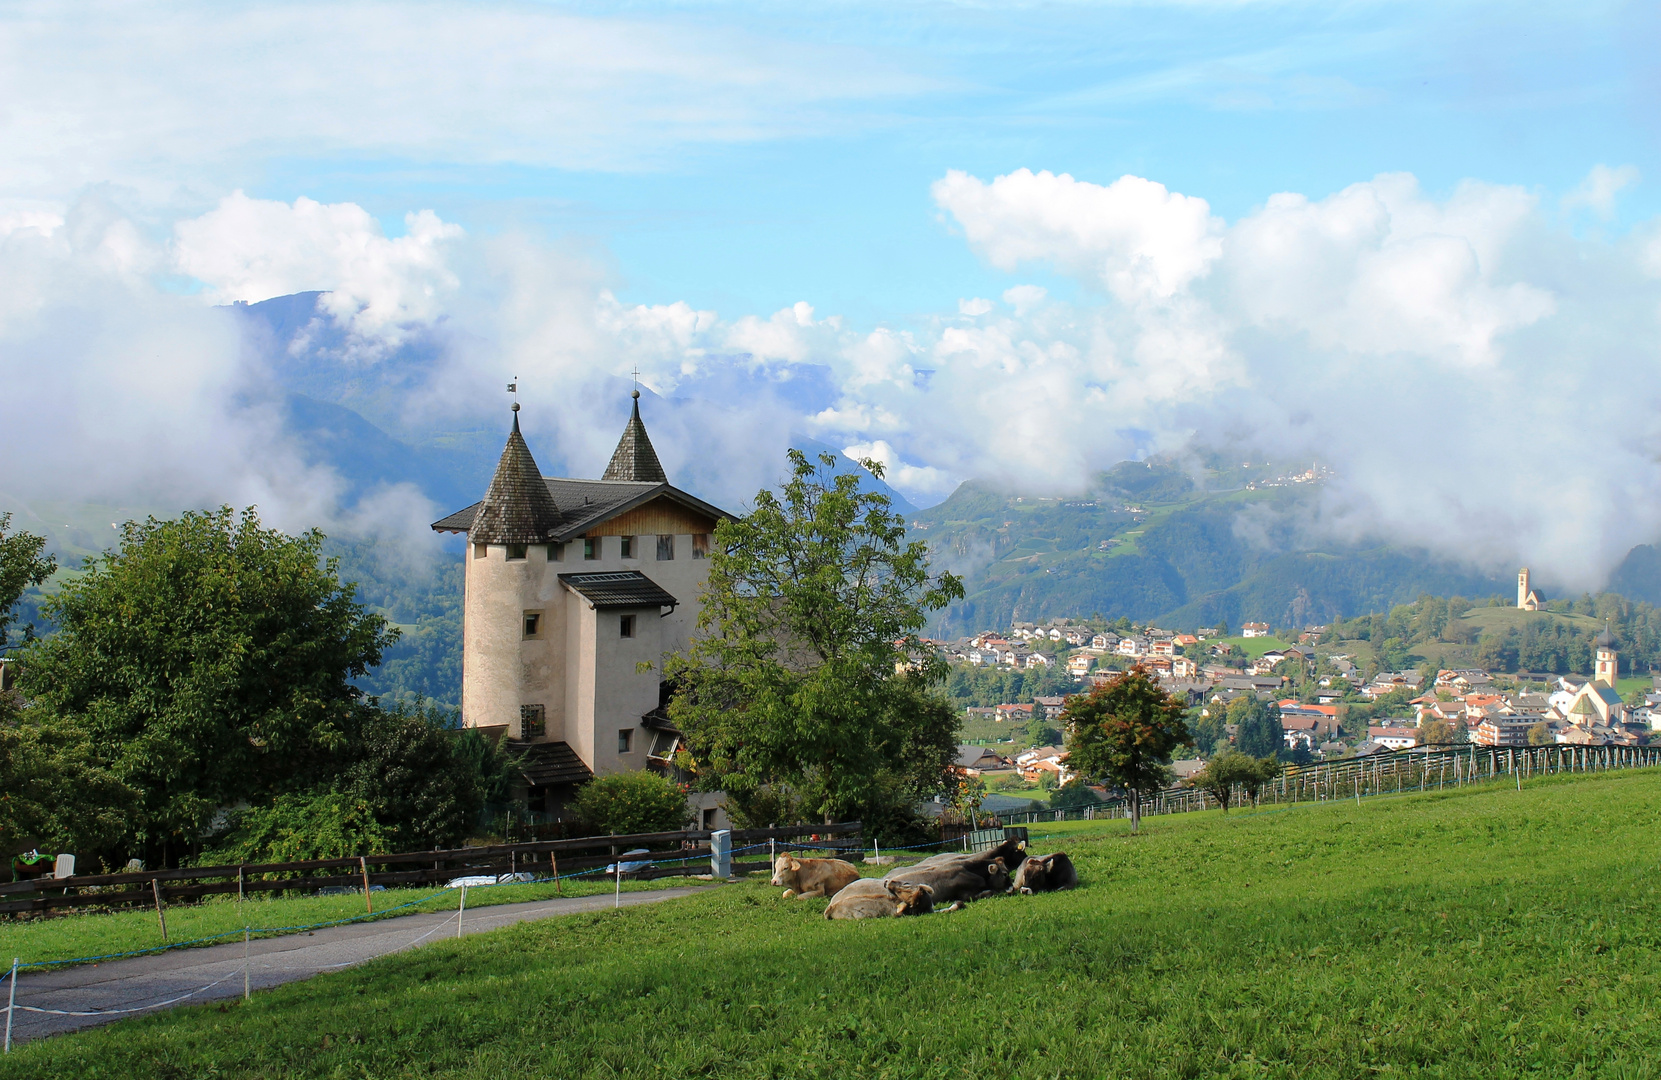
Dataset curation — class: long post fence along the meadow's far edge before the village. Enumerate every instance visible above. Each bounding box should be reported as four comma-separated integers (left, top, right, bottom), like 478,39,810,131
997,743,1661,826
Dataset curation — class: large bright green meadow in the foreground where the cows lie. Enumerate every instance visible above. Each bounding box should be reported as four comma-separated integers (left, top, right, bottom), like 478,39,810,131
0,773,1661,1078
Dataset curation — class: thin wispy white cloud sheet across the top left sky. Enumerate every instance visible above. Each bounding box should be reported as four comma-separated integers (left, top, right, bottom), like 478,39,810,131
0,0,933,201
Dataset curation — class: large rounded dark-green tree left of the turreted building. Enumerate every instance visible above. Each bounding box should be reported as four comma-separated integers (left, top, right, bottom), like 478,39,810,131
22,507,397,859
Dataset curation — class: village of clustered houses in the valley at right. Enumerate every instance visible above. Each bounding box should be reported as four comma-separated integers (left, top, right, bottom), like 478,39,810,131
930,570,1661,808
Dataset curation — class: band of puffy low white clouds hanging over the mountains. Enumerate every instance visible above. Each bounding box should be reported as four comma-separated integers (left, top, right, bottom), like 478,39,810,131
0,169,1661,588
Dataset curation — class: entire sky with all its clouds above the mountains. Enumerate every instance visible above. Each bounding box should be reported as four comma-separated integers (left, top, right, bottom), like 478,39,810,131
0,2,1661,588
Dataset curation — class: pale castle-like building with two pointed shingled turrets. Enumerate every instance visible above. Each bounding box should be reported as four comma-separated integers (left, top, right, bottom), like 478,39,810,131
432,390,731,827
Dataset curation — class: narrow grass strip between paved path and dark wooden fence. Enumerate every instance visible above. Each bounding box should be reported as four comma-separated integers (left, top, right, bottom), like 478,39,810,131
0,866,690,970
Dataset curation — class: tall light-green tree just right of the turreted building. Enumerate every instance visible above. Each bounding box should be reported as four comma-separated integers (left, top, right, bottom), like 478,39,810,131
669,450,963,822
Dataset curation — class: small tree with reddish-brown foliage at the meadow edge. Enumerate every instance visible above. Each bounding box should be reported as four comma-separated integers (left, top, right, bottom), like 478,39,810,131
1061,665,1194,832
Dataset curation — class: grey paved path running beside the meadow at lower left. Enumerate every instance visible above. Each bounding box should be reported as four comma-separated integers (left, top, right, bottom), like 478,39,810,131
0,886,709,1045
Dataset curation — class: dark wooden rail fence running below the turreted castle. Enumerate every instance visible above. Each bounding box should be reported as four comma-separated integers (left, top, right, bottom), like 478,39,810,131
0,821,864,912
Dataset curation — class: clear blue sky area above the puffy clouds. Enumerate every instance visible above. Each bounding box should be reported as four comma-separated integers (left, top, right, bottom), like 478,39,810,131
246,3,1661,321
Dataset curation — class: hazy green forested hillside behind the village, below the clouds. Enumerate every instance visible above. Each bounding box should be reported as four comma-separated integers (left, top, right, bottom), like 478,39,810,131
910,459,1508,635
